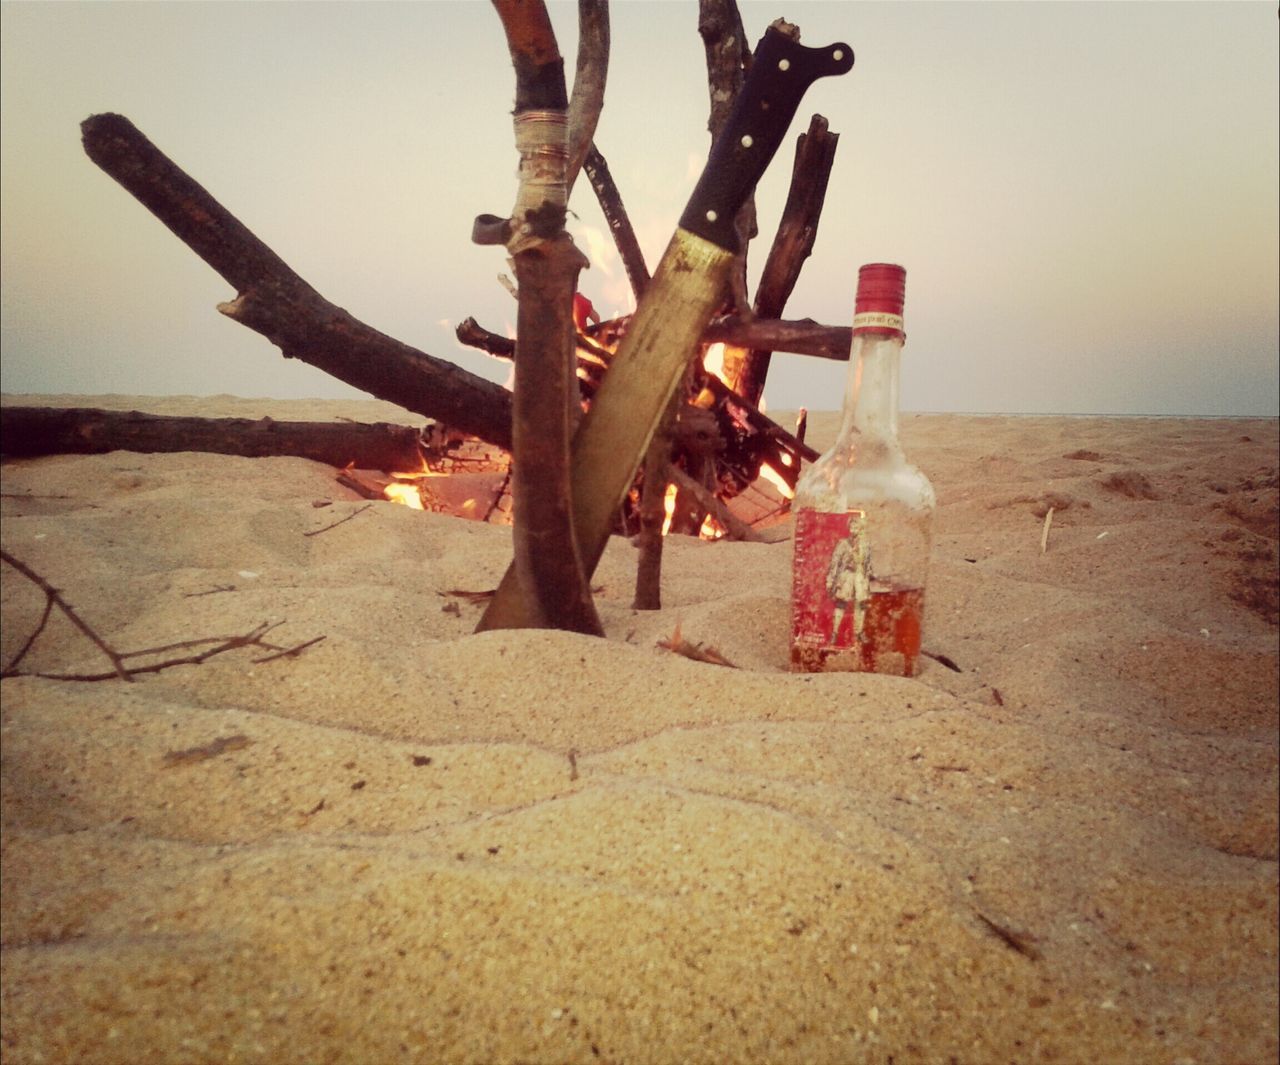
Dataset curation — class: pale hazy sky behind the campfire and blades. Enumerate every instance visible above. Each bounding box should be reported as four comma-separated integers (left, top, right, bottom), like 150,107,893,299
0,0,1280,416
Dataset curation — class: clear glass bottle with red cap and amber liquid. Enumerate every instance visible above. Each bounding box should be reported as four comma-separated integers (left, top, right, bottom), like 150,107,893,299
791,262,936,677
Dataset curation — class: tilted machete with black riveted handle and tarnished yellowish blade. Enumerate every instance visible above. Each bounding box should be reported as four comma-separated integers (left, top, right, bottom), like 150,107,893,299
476,26,854,631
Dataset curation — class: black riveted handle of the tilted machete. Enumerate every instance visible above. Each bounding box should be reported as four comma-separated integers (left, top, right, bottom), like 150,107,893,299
680,26,854,251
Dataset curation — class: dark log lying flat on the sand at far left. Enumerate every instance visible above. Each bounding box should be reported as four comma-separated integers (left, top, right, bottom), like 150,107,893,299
0,407,424,472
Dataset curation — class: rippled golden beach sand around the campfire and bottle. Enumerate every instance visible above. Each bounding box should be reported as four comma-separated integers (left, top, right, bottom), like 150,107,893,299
0,397,1280,1065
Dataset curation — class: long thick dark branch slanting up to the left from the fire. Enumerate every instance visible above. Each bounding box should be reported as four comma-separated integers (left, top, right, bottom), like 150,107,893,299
81,114,511,448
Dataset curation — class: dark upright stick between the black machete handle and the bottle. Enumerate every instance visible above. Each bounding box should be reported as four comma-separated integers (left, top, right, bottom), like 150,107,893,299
737,115,847,403
